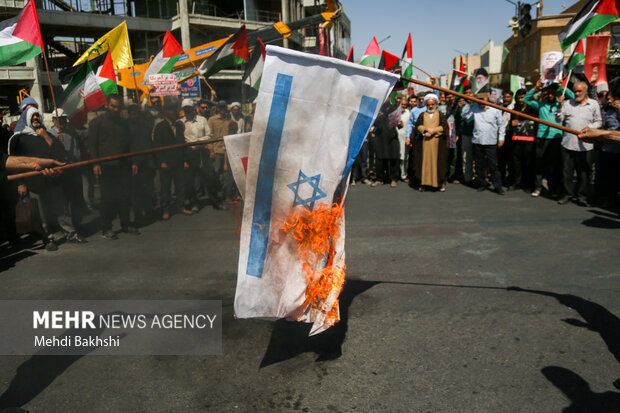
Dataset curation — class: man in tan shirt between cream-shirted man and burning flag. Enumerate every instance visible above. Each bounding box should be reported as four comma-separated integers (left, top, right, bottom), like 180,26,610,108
203,100,236,209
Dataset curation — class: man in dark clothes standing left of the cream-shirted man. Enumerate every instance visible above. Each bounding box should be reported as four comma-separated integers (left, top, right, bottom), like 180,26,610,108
153,99,192,220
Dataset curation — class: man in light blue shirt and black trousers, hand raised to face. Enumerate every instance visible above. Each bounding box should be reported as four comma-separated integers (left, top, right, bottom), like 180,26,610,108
461,93,506,195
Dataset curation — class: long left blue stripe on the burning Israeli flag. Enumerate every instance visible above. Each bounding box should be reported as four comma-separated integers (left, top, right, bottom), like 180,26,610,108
246,73,293,278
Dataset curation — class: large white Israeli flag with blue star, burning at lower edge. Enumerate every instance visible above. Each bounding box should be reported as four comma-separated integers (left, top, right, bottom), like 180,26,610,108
235,46,399,334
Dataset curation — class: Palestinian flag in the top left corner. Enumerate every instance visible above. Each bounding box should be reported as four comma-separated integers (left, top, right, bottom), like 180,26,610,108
0,0,43,66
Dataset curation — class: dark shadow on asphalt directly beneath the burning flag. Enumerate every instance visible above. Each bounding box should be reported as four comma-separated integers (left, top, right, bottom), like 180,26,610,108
260,280,380,368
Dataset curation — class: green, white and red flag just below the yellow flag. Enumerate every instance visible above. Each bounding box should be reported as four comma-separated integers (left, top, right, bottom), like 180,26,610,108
60,62,106,125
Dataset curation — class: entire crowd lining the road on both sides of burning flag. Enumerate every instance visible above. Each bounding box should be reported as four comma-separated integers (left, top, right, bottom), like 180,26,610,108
0,73,620,251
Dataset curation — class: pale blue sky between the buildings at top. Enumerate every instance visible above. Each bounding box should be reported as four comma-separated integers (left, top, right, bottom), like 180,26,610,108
341,0,576,76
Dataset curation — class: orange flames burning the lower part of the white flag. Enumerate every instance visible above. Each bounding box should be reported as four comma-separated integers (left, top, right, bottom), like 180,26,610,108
283,204,345,327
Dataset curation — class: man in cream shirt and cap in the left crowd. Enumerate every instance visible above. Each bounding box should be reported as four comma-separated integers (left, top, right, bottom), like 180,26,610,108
181,99,211,212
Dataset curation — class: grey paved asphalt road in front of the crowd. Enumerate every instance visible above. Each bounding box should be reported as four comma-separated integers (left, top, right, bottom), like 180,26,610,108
0,185,620,412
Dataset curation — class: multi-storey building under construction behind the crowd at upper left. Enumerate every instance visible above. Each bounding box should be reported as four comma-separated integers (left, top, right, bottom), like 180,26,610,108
0,0,351,114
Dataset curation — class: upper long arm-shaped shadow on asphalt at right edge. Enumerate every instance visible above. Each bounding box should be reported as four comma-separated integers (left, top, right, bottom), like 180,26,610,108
507,287,620,362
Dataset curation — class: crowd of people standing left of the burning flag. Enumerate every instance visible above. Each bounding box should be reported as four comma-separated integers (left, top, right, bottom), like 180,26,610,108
0,95,252,251
